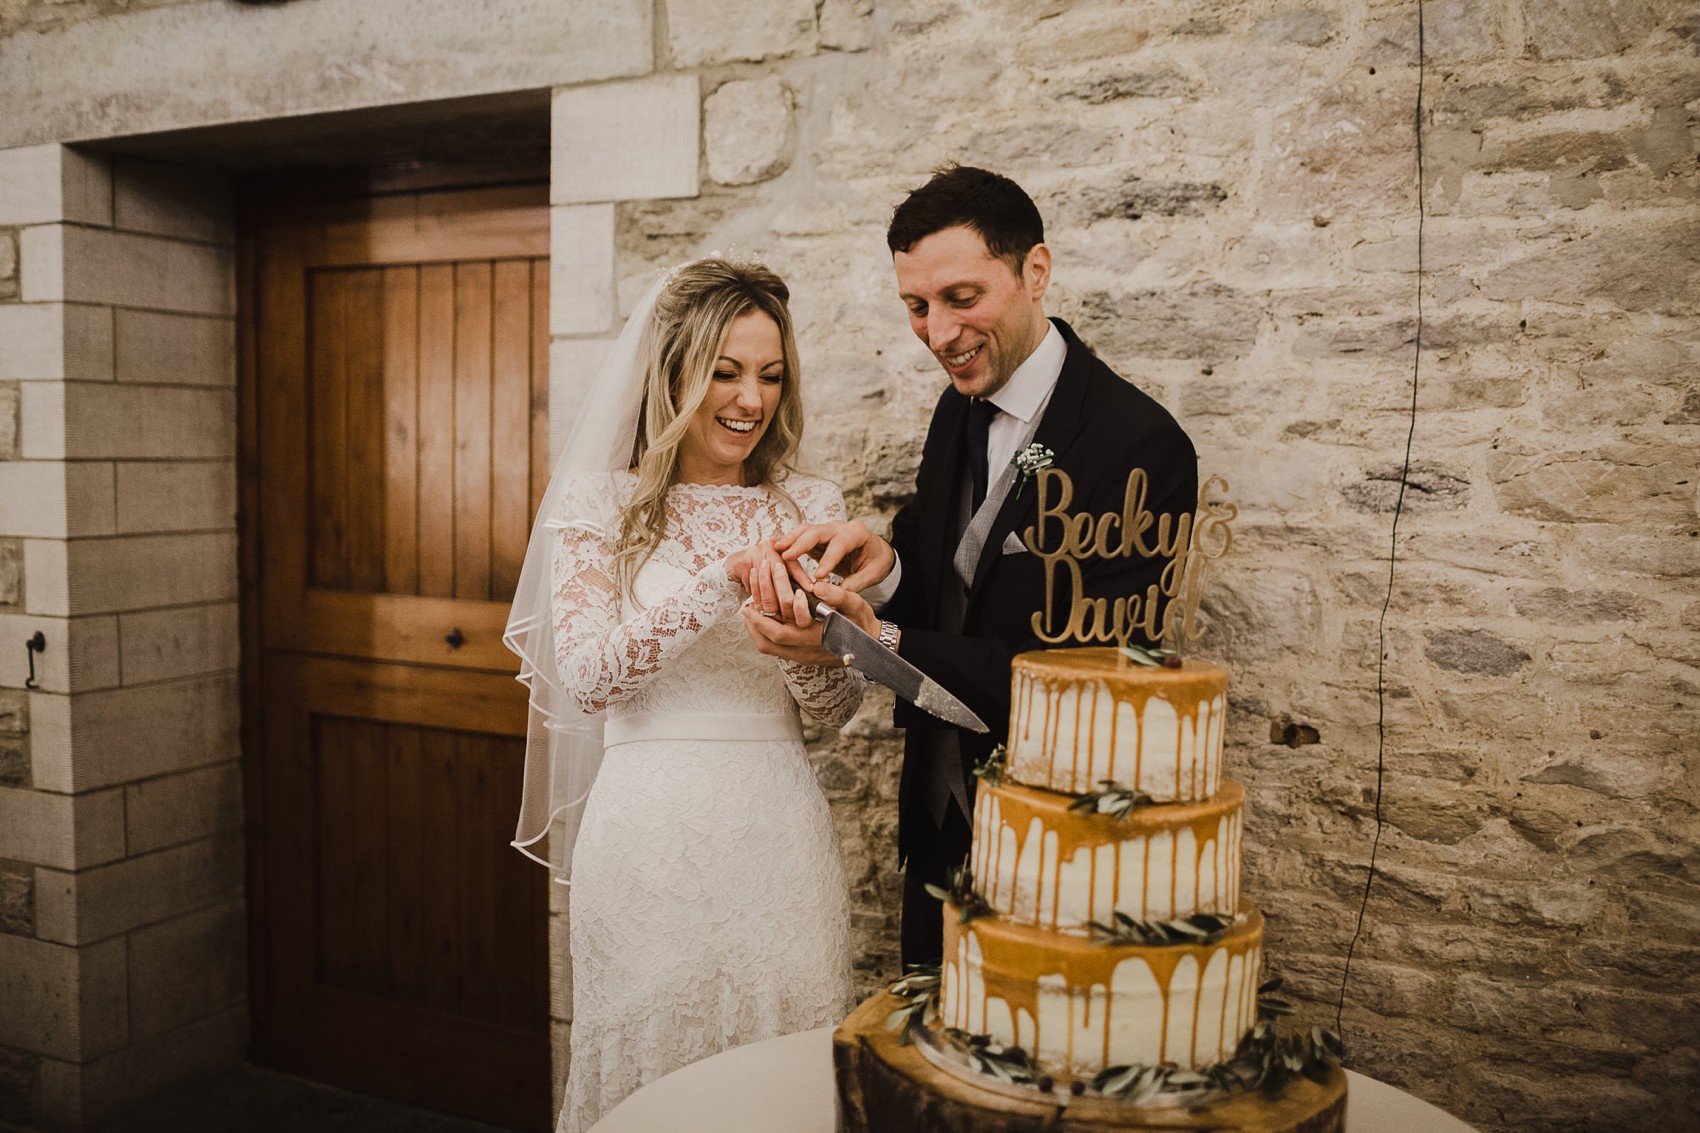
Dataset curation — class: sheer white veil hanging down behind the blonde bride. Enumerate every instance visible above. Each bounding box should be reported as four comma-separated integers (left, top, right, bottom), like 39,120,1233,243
502,274,672,883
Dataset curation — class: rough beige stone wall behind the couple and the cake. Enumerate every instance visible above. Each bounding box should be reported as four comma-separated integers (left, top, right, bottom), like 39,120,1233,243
0,0,1700,1130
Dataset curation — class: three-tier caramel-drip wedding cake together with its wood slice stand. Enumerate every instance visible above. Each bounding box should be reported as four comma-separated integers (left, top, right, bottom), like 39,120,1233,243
835,648,1345,1133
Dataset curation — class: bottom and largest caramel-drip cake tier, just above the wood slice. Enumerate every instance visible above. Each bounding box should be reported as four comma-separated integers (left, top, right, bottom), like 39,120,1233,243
938,902,1263,1077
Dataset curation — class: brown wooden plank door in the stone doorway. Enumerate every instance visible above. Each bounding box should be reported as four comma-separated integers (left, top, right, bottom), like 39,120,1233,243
243,185,549,1130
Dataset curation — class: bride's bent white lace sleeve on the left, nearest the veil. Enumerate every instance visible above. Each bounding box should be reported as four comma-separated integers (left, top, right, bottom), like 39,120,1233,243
549,524,743,713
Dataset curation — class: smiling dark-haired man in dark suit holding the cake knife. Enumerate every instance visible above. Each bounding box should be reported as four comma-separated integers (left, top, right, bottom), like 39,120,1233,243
746,167,1199,965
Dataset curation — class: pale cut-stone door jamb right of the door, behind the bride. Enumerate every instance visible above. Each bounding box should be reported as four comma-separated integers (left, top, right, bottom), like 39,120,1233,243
549,75,702,1111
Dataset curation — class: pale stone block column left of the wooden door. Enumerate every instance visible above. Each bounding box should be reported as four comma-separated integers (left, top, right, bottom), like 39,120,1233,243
0,145,247,1128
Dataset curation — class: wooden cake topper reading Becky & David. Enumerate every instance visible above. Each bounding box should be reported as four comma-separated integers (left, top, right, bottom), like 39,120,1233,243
1022,466,1239,648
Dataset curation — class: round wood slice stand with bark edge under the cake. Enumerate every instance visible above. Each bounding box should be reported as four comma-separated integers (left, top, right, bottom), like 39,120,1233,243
833,992,1346,1133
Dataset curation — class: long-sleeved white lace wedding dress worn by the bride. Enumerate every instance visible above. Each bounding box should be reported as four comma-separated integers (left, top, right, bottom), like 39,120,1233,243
553,473,862,1133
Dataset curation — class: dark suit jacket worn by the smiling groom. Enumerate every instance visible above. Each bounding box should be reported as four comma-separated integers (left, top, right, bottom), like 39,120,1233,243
881,320,1199,861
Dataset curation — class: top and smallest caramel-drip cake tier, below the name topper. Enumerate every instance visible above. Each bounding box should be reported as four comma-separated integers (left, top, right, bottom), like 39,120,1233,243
1005,648,1227,803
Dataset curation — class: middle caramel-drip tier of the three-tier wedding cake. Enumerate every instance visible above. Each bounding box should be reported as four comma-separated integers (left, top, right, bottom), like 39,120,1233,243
969,779,1246,936
